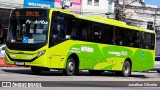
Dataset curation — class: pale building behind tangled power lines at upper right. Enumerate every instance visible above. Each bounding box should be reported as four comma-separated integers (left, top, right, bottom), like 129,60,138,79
115,0,160,30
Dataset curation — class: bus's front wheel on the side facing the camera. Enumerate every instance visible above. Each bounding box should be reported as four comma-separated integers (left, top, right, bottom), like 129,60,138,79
63,57,76,76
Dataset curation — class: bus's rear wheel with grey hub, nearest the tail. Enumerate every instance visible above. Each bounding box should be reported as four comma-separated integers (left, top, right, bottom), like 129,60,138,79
121,61,131,77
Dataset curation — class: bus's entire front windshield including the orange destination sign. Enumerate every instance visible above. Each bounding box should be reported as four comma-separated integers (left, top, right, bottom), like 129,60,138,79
7,9,49,44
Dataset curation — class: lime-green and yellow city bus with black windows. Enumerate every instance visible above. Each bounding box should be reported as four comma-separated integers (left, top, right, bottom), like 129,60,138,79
5,8,155,77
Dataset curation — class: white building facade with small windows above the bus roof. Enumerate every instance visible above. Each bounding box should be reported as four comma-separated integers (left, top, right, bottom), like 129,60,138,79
81,0,115,18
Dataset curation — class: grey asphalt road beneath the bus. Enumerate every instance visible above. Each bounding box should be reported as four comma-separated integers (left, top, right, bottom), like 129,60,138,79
0,67,160,90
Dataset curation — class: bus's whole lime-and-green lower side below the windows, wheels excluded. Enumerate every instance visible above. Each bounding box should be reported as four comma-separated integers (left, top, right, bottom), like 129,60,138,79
48,40,154,71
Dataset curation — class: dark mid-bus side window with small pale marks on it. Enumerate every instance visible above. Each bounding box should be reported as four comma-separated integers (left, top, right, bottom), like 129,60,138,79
89,23,113,44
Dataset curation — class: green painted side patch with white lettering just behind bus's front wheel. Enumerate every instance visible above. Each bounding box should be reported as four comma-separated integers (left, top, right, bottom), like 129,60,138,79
68,41,104,70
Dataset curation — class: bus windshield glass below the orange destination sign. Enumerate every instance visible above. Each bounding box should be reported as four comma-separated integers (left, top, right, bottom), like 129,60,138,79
8,18,48,43
